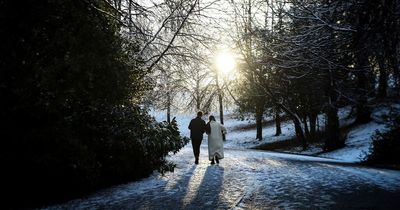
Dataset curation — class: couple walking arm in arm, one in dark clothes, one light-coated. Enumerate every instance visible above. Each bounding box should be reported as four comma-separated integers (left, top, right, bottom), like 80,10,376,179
189,112,226,164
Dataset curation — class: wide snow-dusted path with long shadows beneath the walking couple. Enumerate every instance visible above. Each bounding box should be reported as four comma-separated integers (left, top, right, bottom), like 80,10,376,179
43,143,400,209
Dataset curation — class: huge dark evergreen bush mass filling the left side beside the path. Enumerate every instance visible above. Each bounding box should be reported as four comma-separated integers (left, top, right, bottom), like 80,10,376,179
0,0,187,207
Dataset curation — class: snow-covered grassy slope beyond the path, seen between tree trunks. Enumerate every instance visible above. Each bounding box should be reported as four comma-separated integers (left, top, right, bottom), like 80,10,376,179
152,104,400,162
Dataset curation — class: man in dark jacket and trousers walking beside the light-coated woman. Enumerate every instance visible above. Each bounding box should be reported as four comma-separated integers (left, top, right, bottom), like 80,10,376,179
189,112,206,164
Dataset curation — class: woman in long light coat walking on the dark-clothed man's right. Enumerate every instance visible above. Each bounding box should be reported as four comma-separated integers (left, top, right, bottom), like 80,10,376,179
206,115,226,164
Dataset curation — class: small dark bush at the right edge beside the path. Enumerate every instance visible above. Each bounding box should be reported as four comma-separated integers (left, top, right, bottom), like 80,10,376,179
365,116,400,167
